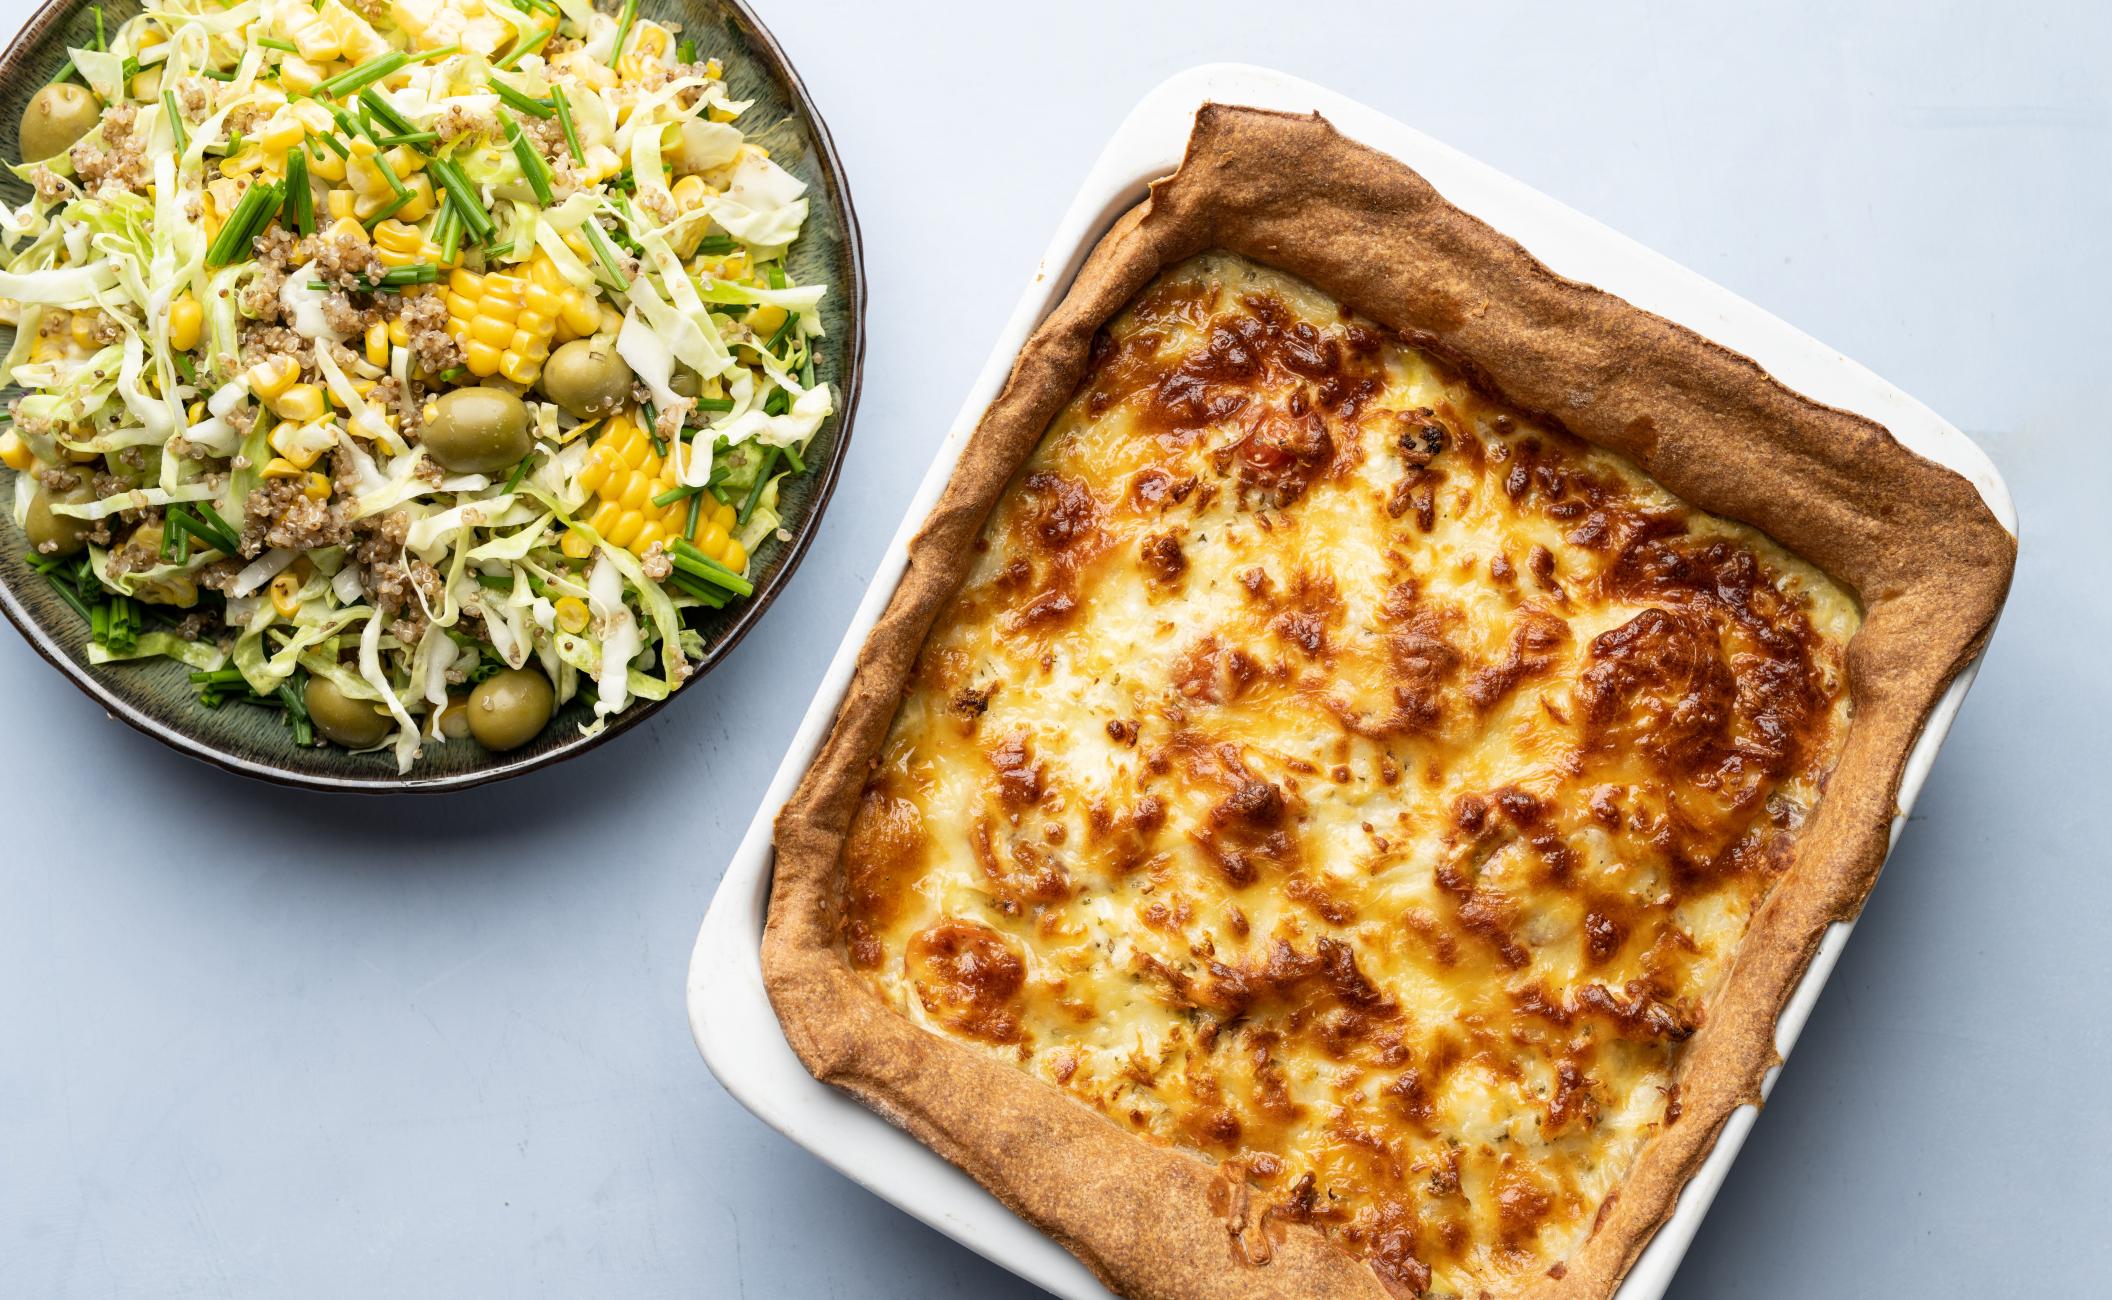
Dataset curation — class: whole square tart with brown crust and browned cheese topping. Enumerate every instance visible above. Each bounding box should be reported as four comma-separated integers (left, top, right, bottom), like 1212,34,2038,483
765,110,2013,1298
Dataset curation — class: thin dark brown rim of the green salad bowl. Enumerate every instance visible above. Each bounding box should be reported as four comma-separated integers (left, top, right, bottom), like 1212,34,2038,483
0,0,866,794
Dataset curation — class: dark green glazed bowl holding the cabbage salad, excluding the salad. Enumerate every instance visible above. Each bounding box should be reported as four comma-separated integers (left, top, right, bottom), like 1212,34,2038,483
0,0,866,791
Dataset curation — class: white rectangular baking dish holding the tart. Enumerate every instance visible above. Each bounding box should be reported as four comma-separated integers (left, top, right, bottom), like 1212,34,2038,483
689,63,2017,1300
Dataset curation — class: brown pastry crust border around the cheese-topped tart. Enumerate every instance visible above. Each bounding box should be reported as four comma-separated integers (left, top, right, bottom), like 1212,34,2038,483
762,106,2015,1300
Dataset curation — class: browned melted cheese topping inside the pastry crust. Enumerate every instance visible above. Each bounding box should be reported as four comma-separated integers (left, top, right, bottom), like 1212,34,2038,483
845,255,1859,1296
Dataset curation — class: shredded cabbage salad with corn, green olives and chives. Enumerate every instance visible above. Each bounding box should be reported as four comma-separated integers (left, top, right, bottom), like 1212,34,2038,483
0,0,834,770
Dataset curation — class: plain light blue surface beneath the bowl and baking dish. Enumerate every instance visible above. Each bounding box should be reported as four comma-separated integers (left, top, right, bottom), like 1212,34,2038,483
0,0,2112,1300
